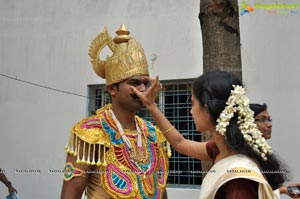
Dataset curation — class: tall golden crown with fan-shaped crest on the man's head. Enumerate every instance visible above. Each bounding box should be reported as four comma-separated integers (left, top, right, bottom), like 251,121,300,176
89,24,149,85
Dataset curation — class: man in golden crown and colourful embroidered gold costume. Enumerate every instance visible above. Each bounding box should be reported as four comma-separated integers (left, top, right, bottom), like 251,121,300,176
61,24,170,199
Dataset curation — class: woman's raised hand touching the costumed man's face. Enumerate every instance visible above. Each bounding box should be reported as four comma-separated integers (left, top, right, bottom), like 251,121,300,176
130,76,162,108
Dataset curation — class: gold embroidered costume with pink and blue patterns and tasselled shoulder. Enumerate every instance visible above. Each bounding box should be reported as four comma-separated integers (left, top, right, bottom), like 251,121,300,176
65,105,169,199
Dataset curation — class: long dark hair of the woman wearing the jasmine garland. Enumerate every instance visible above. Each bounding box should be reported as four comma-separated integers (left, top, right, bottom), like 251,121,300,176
193,71,286,189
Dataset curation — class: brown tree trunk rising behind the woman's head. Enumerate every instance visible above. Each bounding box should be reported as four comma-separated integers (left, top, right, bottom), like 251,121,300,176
199,0,242,177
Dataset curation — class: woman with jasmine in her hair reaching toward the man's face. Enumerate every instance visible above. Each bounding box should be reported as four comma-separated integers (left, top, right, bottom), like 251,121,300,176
131,71,285,199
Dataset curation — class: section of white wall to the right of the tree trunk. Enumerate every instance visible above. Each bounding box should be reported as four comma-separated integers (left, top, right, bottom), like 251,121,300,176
240,0,300,196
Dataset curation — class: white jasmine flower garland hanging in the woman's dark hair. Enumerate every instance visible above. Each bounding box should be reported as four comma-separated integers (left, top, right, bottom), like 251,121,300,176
216,85,272,160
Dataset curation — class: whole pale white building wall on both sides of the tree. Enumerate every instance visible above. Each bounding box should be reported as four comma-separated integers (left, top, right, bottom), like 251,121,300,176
0,0,300,199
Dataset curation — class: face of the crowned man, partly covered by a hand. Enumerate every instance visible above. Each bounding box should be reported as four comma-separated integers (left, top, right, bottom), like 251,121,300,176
111,75,151,112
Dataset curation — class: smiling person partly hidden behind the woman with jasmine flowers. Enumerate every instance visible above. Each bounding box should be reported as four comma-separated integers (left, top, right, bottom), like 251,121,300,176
250,104,300,198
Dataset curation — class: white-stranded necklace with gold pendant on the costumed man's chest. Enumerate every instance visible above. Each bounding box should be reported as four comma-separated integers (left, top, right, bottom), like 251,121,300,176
110,109,147,164
